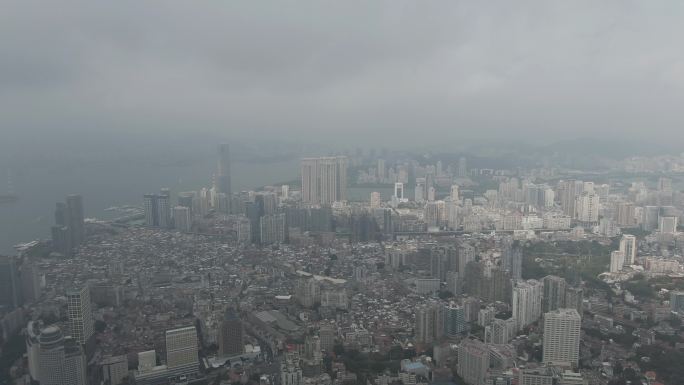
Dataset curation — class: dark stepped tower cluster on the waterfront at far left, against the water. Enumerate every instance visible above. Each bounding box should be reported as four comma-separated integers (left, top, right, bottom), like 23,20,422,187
52,195,85,255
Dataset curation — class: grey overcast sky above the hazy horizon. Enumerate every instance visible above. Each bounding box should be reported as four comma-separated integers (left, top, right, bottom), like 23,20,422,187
0,0,684,147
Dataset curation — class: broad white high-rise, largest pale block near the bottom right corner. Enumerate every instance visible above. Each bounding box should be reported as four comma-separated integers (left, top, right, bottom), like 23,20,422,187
542,309,582,367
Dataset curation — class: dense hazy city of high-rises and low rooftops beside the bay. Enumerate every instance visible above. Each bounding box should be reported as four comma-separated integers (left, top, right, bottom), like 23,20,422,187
0,144,684,385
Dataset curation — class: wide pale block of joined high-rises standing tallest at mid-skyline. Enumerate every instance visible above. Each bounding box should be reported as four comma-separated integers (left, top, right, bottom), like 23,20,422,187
301,156,347,205
